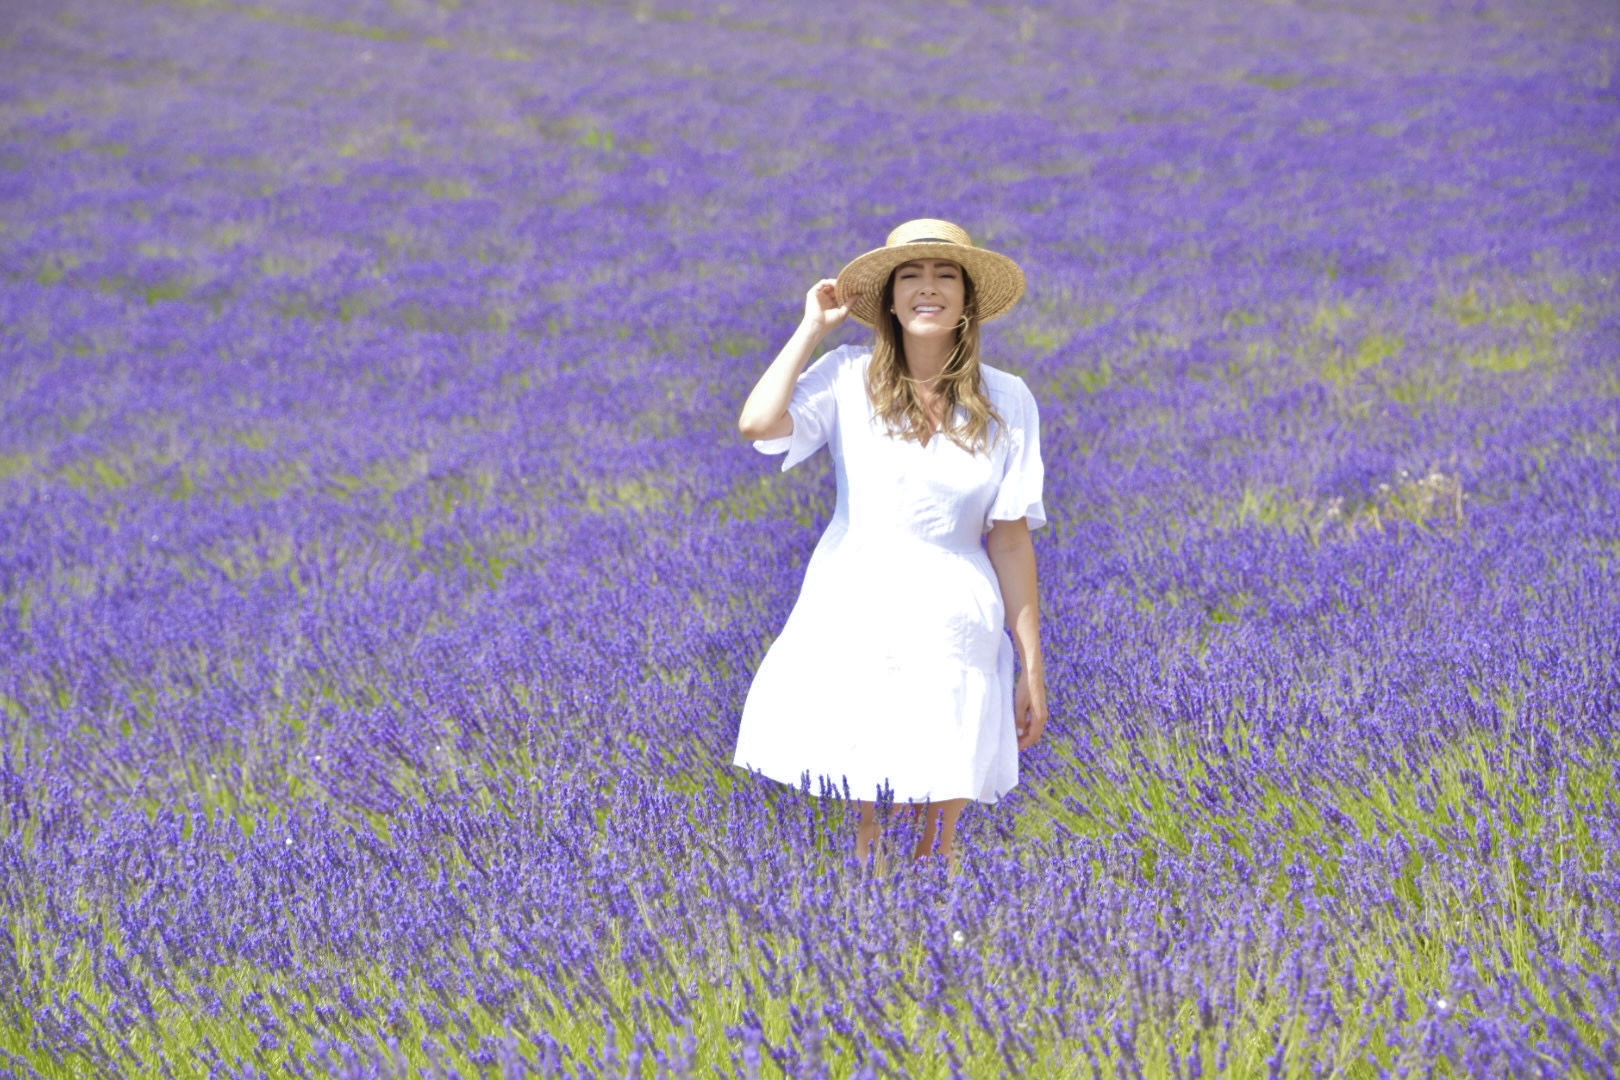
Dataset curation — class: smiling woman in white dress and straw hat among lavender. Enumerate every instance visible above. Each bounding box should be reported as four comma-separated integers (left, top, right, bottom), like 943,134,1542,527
734,219,1047,863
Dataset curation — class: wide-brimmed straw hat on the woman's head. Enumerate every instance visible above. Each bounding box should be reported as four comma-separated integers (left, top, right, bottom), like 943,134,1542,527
838,217,1024,325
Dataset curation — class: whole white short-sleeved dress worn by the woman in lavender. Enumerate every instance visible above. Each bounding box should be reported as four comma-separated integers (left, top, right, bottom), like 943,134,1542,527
732,345,1047,803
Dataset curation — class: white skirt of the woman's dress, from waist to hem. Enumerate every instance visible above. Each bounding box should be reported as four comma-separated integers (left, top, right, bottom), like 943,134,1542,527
735,531,1017,803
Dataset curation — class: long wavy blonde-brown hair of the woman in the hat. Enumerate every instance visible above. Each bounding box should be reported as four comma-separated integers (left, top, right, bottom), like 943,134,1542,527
867,269,1001,453
